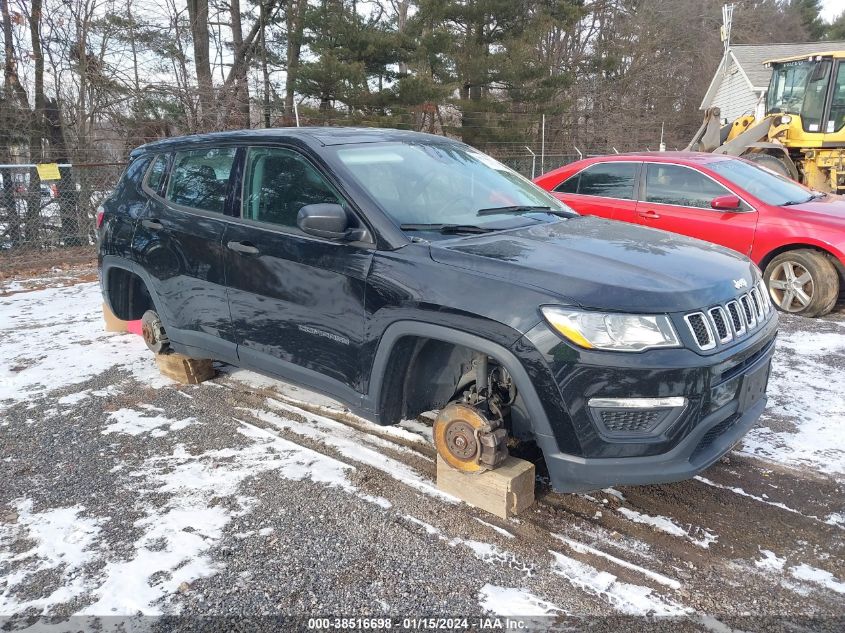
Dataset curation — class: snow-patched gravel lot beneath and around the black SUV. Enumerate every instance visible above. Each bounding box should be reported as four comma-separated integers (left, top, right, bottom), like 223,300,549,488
0,270,845,633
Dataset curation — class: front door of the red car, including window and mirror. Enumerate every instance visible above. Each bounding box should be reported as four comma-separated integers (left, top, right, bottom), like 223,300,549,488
637,163,758,256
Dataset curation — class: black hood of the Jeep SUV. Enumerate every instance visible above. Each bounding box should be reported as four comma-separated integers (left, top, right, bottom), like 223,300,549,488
431,216,759,313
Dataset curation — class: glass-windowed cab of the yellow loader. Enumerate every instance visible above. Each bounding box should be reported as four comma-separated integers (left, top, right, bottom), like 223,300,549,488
766,51,845,138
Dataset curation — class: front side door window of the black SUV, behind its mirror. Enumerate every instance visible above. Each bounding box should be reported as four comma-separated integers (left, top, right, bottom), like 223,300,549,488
243,147,343,228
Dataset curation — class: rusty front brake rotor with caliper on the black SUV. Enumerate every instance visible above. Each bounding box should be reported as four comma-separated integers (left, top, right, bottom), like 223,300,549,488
434,402,508,473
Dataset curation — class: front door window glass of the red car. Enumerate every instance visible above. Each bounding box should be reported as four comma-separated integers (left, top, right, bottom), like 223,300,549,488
645,163,734,209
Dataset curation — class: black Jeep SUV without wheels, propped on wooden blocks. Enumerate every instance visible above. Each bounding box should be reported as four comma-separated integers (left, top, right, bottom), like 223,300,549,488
99,128,777,491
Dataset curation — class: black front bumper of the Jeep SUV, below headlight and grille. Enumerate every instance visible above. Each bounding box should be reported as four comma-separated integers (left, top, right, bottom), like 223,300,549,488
512,317,777,492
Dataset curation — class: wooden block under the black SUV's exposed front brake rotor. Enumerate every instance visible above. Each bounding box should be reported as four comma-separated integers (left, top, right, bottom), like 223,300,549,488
437,455,535,519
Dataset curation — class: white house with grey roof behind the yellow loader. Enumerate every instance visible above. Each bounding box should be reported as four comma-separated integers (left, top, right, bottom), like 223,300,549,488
701,41,845,122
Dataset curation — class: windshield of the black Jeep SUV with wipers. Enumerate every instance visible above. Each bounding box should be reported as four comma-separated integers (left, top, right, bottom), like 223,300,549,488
335,143,574,230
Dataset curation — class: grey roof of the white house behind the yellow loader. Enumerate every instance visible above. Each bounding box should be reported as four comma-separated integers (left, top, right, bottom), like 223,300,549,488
701,41,845,110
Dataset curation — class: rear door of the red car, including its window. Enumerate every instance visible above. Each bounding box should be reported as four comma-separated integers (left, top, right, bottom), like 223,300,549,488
552,161,642,222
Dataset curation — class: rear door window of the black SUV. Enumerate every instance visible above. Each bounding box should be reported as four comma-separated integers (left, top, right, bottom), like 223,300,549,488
166,147,235,213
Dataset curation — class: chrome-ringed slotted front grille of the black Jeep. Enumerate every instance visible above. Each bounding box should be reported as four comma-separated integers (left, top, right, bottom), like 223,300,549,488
684,290,771,351
